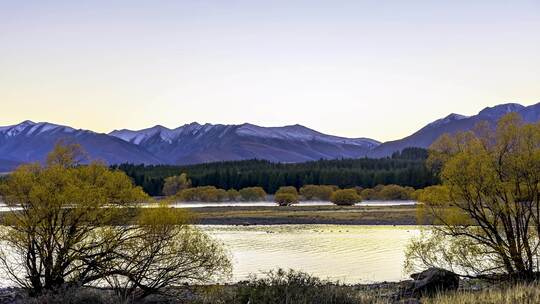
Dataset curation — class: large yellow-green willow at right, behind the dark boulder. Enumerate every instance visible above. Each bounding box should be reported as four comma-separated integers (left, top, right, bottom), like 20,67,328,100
406,114,540,278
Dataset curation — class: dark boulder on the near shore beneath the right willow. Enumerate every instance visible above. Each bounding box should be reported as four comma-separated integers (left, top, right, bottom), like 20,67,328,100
405,267,459,296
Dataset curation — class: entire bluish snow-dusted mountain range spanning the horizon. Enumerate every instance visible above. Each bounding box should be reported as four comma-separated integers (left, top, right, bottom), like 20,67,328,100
0,103,540,172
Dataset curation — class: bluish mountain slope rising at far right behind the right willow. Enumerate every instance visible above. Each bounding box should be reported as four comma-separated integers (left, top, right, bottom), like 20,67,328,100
368,103,540,157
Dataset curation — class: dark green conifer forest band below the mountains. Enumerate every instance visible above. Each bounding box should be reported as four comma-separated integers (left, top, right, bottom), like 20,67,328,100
112,148,438,196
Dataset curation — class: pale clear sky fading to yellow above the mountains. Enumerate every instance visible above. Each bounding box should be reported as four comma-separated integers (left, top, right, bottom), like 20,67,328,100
0,0,540,141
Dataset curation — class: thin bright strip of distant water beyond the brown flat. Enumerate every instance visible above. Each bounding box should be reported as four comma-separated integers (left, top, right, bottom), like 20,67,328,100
171,201,416,208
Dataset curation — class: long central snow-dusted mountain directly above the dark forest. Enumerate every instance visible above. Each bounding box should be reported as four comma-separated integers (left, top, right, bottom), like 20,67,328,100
109,123,379,164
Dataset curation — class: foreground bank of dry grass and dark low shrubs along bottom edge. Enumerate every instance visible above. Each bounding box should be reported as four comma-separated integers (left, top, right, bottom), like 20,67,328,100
7,272,540,304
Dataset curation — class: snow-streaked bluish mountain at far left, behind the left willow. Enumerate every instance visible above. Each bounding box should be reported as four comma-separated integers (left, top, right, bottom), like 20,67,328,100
0,120,161,169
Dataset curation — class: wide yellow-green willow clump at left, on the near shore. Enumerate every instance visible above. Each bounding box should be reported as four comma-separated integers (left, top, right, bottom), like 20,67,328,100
0,144,230,298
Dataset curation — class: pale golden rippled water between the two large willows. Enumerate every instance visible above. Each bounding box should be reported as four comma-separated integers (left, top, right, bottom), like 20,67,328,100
200,225,420,284
